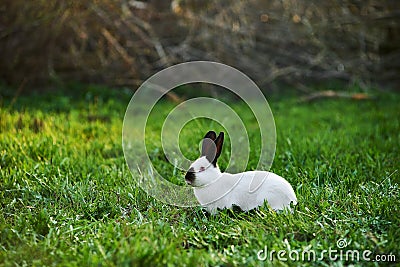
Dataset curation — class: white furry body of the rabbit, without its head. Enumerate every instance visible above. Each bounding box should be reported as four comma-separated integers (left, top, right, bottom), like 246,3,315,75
194,171,297,213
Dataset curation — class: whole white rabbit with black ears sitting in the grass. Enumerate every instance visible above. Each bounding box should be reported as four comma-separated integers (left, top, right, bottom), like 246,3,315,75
185,131,297,214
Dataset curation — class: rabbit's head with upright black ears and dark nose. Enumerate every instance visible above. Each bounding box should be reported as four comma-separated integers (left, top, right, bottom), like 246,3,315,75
185,131,224,187
